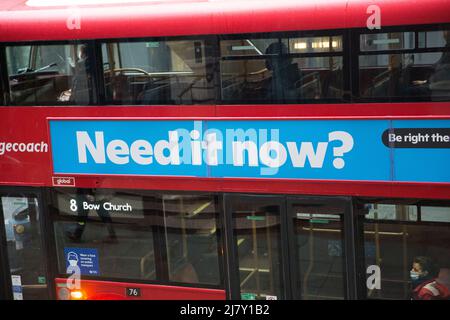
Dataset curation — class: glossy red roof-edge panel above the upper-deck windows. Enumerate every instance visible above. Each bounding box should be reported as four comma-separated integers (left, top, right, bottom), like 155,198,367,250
0,0,450,41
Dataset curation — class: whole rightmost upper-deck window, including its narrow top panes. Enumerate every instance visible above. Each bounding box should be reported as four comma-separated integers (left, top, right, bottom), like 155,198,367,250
359,30,450,101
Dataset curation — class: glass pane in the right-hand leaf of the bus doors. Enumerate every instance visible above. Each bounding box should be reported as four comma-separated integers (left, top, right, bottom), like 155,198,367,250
291,203,345,300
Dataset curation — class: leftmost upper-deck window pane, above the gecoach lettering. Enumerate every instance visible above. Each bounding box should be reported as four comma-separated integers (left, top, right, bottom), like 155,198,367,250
6,44,96,105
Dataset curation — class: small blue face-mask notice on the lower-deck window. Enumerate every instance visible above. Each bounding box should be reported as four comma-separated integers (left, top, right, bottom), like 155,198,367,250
64,248,100,276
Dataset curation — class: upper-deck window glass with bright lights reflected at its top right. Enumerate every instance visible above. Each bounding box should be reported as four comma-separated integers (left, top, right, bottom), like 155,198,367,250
220,37,343,103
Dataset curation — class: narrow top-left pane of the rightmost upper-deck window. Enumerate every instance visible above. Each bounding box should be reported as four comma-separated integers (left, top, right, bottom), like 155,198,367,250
360,32,415,51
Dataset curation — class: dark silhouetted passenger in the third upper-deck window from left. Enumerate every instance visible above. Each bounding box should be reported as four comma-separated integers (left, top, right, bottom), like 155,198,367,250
265,42,301,101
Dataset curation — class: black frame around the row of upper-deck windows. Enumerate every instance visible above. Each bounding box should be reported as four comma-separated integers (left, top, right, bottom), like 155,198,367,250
0,23,450,107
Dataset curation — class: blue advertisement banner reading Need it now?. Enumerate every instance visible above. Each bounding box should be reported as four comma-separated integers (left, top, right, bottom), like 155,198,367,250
50,119,450,182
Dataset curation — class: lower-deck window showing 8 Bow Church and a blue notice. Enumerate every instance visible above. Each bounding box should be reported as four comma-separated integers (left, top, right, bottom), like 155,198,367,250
53,189,222,286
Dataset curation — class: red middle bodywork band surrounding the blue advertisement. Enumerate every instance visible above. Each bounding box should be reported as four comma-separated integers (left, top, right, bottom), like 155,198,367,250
0,103,450,199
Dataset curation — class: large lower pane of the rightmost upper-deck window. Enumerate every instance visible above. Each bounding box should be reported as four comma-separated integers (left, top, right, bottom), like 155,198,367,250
359,52,450,101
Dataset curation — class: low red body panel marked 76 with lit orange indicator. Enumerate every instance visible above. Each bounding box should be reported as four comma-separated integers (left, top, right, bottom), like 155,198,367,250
55,278,225,300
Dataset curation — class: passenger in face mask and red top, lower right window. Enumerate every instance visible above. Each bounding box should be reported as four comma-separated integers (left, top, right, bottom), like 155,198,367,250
410,257,450,300
